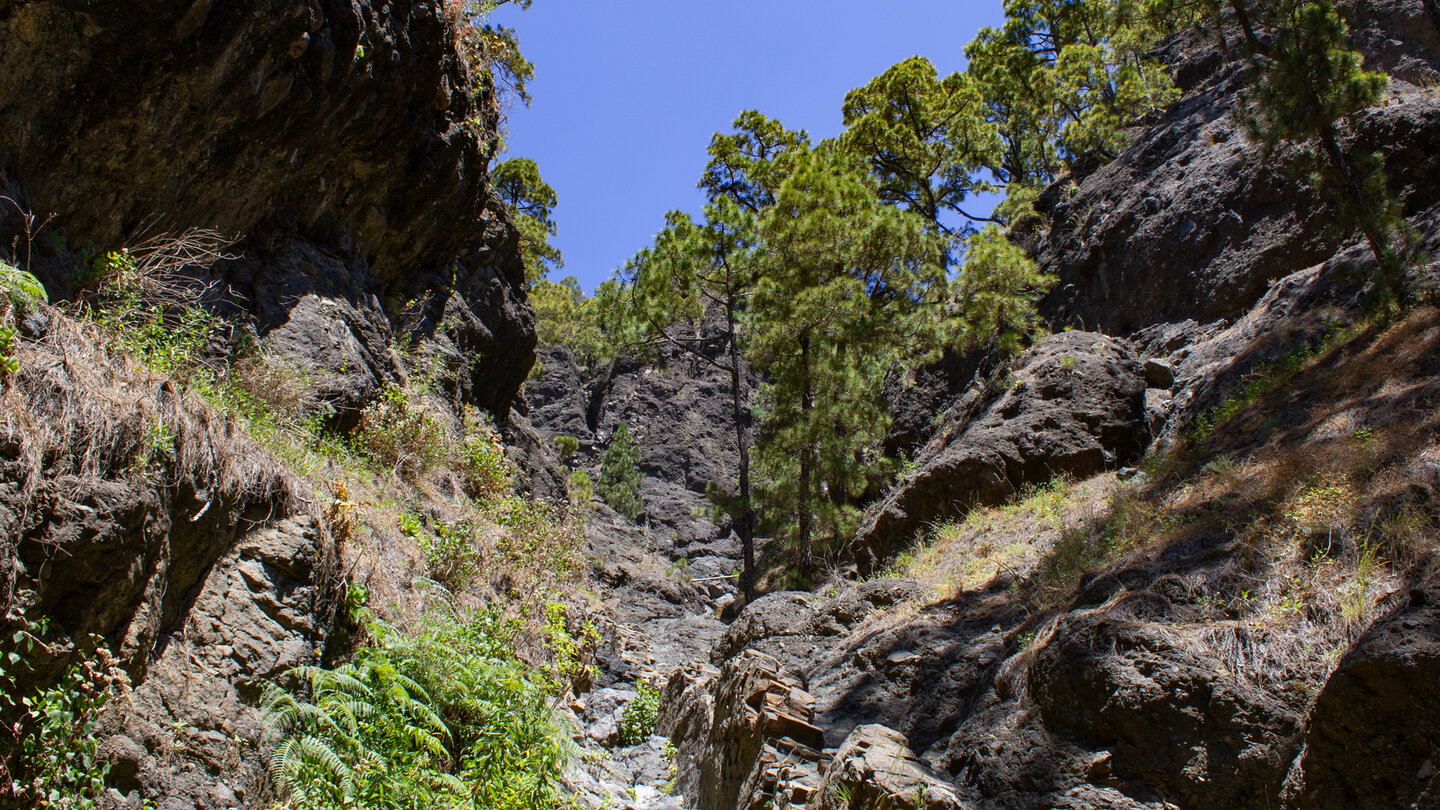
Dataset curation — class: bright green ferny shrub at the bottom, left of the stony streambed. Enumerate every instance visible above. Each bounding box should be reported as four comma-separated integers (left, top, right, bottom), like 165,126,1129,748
264,608,569,810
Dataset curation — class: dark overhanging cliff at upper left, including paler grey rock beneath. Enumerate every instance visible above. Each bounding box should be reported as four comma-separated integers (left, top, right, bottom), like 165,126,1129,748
0,0,534,430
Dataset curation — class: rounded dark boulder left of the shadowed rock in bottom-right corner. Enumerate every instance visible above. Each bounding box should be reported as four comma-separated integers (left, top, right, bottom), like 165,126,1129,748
1027,608,1302,810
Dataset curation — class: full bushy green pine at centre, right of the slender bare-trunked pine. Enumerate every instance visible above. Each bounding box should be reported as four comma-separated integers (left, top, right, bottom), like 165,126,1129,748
746,144,945,578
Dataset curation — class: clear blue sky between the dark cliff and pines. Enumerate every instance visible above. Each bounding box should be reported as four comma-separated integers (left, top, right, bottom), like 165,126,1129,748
492,0,1004,290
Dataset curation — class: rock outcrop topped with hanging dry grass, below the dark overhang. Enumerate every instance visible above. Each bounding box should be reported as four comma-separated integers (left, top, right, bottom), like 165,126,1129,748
0,311,331,810
